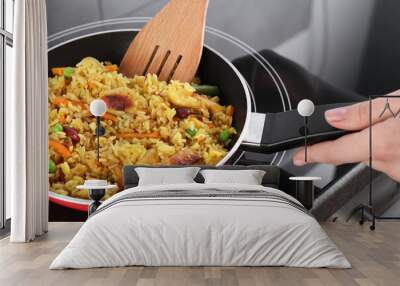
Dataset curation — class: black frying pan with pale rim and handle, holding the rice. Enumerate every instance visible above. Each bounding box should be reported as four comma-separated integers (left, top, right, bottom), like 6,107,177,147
48,30,350,209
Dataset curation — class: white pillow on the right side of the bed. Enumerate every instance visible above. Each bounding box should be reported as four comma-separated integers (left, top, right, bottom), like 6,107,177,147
200,169,265,185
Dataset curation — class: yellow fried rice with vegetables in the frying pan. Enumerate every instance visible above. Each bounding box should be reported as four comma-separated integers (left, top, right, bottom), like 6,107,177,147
48,57,236,199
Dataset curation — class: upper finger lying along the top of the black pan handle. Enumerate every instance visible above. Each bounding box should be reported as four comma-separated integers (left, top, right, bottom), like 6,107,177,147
325,90,400,130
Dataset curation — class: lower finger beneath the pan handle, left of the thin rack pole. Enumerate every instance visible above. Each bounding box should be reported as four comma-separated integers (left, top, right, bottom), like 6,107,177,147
293,129,369,166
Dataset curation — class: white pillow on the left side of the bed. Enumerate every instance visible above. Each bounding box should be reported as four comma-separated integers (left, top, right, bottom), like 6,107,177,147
135,167,200,186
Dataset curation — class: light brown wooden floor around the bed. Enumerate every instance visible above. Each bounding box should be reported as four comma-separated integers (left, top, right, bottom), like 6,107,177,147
0,222,400,286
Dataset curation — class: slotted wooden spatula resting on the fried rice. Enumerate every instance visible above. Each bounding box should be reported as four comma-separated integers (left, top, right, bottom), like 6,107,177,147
119,0,208,82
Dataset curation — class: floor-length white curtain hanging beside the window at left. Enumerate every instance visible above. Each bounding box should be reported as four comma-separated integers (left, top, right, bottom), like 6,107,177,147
6,0,48,242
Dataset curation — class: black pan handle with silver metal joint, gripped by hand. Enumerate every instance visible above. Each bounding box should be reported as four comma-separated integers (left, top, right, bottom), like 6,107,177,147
241,103,351,153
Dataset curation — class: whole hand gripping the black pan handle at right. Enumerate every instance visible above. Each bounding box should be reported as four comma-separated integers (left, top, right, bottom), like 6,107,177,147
293,90,400,182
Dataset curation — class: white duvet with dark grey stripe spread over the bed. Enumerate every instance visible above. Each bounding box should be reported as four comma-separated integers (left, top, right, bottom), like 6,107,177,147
50,184,350,269
